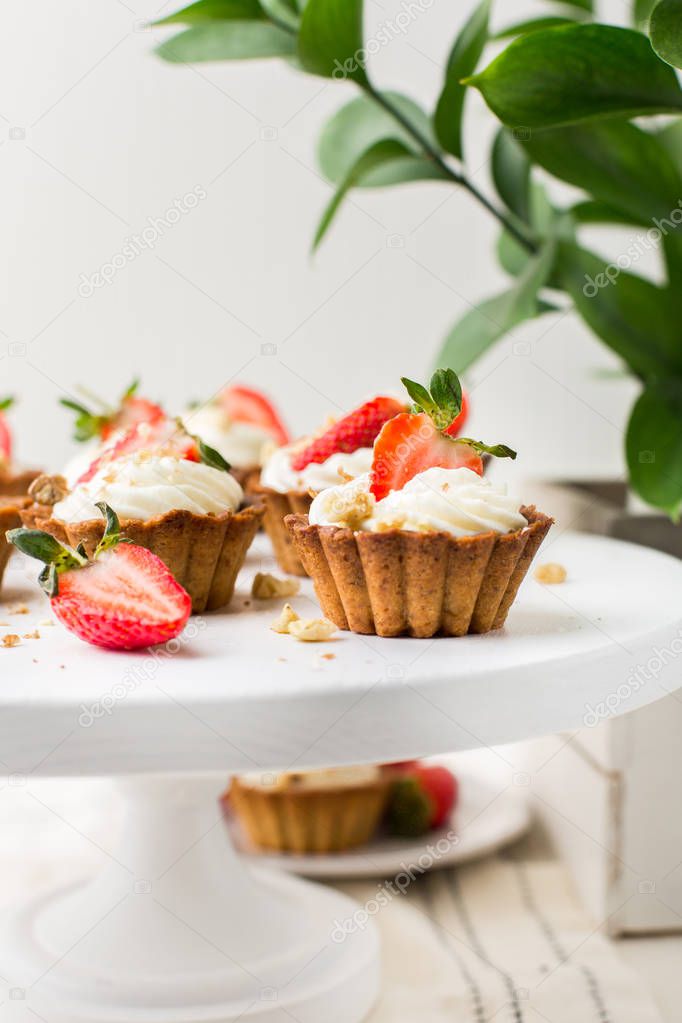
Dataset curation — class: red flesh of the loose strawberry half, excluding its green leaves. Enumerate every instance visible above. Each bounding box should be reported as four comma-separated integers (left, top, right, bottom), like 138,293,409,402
52,544,192,650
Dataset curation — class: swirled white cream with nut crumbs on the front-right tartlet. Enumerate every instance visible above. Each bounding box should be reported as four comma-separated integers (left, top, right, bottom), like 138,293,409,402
309,466,528,536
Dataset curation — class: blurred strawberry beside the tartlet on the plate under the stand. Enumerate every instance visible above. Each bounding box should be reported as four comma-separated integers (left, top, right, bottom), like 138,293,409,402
387,762,459,837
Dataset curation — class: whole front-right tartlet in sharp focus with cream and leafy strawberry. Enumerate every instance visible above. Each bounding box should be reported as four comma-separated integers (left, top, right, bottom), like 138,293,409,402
286,370,552,638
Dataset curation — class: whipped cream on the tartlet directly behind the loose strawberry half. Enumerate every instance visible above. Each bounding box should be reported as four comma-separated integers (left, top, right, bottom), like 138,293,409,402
53,451,243,522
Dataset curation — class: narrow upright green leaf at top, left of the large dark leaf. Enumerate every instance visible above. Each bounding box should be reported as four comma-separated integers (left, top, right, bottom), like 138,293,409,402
434,0,491,160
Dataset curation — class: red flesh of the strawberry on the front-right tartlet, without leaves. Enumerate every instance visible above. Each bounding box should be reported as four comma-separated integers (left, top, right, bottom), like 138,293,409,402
370,412,483,501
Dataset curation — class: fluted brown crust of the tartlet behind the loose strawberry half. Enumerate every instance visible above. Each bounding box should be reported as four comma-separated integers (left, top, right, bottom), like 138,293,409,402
21,504,263,614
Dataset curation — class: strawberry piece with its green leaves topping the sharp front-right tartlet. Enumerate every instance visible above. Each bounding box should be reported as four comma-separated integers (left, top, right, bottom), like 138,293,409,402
370,369,516,501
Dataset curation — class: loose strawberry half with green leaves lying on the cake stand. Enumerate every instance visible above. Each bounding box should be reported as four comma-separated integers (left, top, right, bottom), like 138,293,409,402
7,503,192,650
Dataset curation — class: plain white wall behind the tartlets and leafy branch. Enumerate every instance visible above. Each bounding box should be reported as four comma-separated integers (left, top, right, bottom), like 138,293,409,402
0,0,633,477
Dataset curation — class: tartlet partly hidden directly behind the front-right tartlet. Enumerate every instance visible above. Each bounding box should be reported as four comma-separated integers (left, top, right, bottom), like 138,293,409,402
255,397,405,576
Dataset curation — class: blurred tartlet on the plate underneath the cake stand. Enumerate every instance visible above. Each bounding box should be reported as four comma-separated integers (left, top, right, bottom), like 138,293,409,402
229,766,391,853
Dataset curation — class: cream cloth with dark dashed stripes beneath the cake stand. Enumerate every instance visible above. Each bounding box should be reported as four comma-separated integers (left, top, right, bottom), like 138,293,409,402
338,856,661,1023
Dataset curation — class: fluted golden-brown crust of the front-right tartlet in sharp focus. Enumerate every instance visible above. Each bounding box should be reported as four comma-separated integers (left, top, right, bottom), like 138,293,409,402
286,505,553,638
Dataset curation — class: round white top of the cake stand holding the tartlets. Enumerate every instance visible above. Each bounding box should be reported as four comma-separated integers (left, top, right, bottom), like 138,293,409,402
0,533,682,774
